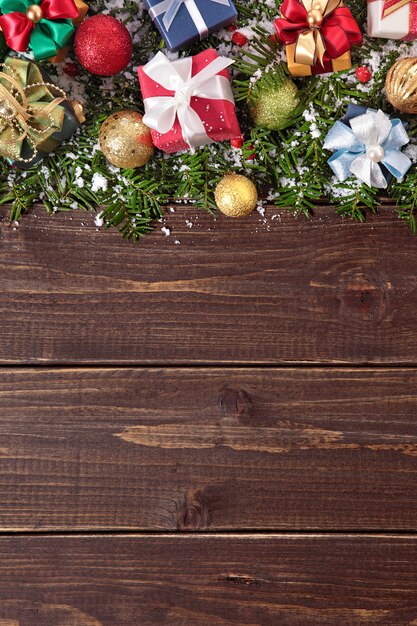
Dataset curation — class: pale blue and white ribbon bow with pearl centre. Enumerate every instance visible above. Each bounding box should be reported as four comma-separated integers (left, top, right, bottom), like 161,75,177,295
323,110,411,189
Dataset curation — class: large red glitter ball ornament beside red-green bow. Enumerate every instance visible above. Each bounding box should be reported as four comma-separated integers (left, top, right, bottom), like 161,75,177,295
74,15,132,76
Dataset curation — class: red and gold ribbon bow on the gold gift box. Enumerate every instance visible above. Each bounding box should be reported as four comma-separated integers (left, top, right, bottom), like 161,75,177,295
275,0,362,66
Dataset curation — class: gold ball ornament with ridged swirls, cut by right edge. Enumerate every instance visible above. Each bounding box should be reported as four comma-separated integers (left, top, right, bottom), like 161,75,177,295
385,57,417,113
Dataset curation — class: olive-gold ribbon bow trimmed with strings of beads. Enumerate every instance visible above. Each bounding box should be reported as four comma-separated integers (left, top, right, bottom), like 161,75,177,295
0,58,67,163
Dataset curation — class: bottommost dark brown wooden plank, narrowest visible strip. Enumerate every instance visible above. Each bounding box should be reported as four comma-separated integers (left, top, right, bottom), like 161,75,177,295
0,535,417,626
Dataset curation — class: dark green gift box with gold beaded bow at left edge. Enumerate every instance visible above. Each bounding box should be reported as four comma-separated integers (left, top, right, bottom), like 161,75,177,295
0,57,84,169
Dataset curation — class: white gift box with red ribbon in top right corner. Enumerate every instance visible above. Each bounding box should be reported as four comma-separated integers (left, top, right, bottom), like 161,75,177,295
368,0,417,41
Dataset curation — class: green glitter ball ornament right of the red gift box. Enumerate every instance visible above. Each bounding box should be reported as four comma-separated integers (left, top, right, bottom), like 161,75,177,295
248,65,300,130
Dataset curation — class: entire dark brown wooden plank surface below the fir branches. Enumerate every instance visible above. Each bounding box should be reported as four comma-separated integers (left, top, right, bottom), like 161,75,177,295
0,202,417,626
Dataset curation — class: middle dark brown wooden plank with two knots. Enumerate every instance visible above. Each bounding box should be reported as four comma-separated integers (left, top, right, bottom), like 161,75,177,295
0,368,417,531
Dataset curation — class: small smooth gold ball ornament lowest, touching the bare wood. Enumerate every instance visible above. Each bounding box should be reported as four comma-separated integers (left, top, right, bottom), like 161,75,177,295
214,173,258,217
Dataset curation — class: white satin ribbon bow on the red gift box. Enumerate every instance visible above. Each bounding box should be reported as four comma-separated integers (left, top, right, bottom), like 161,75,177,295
143,52,234,150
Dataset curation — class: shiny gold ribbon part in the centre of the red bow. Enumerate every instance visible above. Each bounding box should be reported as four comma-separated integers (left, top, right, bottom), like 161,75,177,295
295,0,342,65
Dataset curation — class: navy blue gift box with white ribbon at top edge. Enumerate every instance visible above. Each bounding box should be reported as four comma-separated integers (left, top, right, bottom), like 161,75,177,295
145,0,237,52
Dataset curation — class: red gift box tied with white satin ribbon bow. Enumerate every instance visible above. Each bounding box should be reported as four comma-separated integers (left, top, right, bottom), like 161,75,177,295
138,48,241,153
